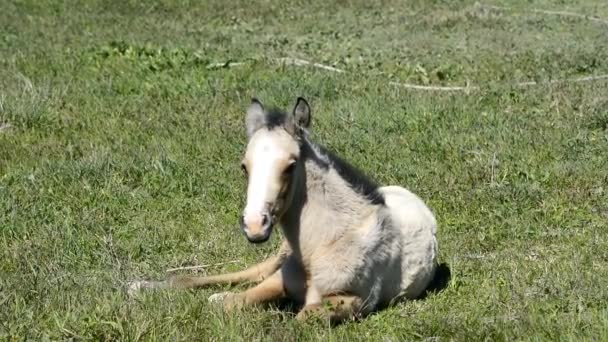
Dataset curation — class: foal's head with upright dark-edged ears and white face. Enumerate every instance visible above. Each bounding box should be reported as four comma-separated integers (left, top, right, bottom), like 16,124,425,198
241,98,311,242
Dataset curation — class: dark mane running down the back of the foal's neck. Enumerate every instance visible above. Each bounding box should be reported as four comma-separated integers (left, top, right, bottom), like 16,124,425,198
309,142,384,204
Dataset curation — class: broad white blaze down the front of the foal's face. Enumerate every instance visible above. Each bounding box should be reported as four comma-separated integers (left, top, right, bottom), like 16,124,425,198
243,129,295,230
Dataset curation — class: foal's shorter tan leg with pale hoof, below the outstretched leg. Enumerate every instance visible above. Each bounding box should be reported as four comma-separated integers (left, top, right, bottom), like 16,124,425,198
209,269,285,310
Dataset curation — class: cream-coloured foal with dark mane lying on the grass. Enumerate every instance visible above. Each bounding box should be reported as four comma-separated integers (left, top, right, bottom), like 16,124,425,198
130,98,437,321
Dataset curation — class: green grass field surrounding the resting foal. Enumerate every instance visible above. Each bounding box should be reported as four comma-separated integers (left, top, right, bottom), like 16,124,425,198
0,0,608,341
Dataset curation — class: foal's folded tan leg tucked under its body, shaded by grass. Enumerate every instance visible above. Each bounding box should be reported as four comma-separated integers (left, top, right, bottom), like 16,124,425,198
296,295,363,323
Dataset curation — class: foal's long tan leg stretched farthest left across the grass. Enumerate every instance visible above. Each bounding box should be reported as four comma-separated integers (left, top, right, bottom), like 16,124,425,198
129,242,290,294
